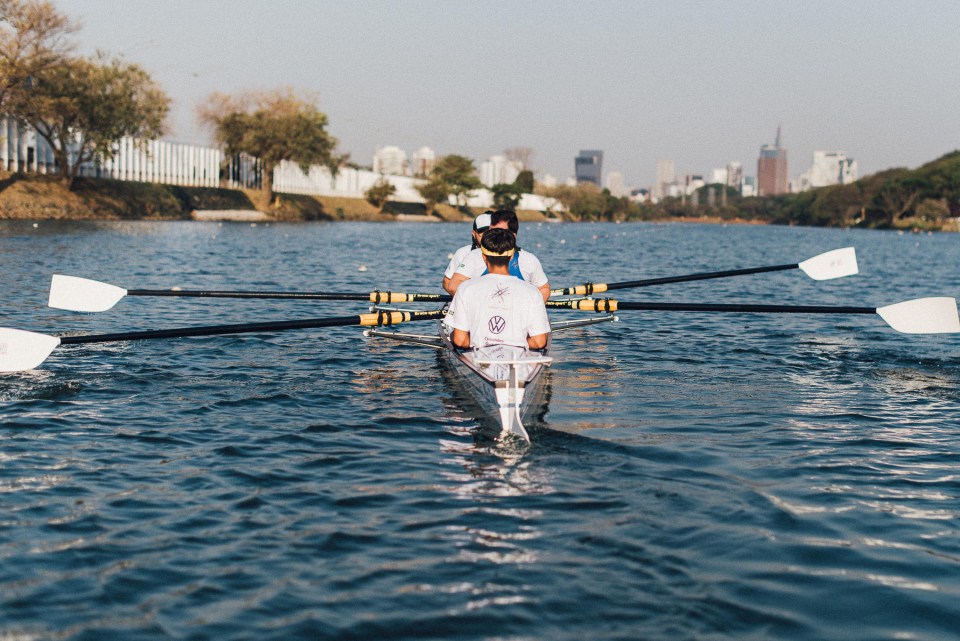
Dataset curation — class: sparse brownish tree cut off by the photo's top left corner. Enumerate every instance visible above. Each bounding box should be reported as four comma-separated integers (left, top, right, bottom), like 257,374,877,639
0,0,77,112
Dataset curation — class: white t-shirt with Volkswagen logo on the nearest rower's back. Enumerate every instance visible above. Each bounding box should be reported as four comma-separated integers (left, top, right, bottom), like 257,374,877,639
445,274,550,347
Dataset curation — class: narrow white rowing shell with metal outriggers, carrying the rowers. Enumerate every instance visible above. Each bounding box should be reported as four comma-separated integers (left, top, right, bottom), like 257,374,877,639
364,315,617,441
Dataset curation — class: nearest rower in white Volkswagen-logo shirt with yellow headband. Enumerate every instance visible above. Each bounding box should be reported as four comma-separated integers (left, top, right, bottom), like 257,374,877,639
445,228,550,349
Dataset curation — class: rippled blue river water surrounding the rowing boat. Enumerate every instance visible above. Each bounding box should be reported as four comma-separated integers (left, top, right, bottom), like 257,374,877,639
0,222,960,641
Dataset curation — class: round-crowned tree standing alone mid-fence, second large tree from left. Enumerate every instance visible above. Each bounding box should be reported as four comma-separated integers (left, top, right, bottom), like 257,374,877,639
200,88,341,203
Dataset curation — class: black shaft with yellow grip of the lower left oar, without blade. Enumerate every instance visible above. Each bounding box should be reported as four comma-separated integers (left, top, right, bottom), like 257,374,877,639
60,311,444,345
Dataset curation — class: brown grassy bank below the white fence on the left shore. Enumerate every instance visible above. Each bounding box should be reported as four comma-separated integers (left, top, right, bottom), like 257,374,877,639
0,173,543,222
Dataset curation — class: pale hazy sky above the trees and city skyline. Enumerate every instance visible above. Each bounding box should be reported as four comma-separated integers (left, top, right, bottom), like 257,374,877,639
53,0,960,186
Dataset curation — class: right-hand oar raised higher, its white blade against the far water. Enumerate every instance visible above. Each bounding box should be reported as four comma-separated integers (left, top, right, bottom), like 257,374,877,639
550,247,857,296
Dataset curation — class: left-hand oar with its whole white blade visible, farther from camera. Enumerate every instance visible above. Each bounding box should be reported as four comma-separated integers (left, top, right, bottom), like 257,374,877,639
47,274,452,312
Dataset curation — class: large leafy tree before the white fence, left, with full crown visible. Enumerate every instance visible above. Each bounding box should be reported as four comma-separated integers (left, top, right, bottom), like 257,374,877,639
11,54,170,189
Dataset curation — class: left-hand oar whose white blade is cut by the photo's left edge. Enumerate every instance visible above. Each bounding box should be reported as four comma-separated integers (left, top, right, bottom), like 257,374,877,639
0,310,445,372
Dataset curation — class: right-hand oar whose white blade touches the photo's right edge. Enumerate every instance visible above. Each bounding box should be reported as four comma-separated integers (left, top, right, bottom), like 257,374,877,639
547,296,960,334
